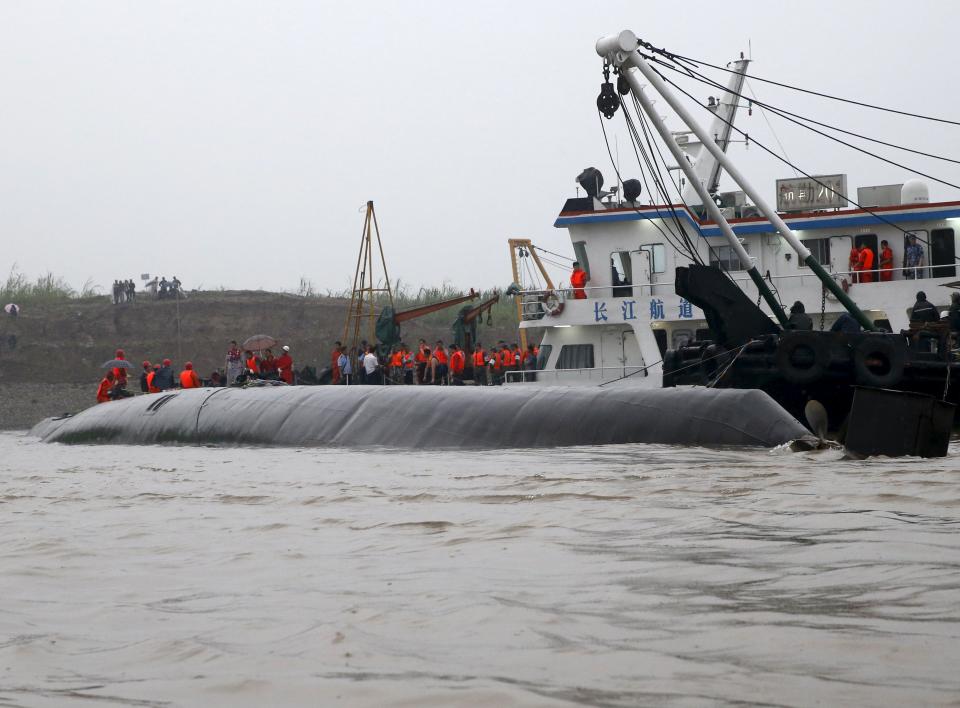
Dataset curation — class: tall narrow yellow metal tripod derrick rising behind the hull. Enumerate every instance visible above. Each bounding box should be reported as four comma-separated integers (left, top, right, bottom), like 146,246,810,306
343,201,393,351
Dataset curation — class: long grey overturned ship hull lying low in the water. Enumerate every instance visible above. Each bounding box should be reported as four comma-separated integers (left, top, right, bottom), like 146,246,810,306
34,386,808,448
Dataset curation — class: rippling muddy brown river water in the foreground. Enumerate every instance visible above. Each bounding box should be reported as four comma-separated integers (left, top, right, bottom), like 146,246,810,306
0,433,960,707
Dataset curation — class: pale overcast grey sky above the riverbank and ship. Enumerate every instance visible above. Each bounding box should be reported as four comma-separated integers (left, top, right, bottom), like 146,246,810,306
0,0,960,290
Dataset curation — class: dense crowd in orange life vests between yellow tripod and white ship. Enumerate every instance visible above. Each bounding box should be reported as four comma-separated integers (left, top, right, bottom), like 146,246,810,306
330,339,539,386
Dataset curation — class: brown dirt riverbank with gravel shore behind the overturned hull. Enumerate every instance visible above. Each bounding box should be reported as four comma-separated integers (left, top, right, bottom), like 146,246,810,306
0,292,516,428
